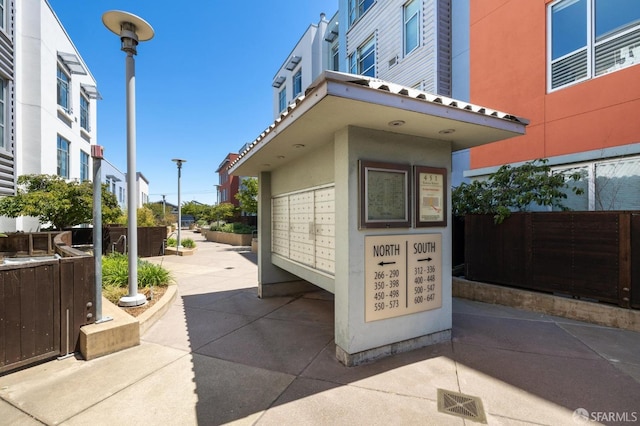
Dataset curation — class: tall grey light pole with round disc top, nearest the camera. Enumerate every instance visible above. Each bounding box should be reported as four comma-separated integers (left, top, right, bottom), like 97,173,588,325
102,10,153,306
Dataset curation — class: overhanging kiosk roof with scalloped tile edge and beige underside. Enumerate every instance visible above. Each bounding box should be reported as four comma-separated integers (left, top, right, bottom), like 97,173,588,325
229,71,529,176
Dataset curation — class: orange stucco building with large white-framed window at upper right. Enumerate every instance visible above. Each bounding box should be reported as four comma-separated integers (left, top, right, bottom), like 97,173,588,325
467,0,640,210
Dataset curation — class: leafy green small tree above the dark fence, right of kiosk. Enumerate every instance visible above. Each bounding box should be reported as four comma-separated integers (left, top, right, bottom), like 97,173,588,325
452,159,584,223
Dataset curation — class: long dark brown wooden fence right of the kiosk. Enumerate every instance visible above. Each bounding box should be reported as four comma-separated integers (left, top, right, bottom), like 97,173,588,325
464,212,640,309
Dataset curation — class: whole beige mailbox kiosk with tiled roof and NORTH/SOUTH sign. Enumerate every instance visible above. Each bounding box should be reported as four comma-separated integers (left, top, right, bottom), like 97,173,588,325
229,71,527,365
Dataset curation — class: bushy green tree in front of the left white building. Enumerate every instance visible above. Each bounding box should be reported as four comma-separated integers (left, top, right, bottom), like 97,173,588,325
0,175,122,229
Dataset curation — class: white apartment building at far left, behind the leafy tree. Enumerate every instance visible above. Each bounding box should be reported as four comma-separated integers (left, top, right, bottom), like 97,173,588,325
0,0,100,232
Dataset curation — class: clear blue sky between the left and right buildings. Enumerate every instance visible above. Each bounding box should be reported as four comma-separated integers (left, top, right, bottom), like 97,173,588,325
49,0,338,204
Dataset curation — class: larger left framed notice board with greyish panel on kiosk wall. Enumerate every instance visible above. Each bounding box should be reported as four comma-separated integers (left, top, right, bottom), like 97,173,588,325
360,160,411,228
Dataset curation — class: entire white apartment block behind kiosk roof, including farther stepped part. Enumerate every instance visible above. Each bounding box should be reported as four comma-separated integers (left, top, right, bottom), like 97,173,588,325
272,0,458,117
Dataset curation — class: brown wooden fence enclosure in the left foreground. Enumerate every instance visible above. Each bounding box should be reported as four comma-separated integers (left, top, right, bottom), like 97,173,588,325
0,233,96,373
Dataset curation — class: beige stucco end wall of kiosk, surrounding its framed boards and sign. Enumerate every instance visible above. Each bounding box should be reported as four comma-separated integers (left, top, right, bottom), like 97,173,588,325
334,127,452,354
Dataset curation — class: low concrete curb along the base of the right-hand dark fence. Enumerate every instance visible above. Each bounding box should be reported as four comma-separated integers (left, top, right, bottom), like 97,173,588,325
453,277,640,331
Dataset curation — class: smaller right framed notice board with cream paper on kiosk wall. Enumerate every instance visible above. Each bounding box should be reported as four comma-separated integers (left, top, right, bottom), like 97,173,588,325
413,166,447,228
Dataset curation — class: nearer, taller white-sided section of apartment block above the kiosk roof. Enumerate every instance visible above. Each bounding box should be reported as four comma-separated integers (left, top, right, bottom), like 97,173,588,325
339,0,452,96
